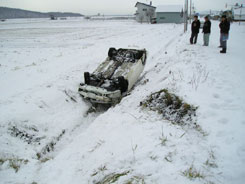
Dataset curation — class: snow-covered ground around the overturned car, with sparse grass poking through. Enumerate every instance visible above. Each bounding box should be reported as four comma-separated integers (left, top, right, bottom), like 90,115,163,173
0,19,245,184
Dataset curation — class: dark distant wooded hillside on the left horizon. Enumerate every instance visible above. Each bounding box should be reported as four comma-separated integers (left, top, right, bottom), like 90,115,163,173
0,7,83,19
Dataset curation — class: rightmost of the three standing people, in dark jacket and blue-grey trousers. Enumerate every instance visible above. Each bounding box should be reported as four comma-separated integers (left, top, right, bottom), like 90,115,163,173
219,15,230,53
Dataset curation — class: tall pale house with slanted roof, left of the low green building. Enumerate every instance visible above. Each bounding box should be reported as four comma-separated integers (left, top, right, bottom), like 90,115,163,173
135,2,156,23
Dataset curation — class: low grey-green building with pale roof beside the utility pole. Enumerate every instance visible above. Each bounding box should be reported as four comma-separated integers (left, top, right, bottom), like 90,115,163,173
156,5,184,24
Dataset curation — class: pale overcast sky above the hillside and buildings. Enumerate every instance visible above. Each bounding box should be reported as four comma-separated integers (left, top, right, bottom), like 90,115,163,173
0,0,245,15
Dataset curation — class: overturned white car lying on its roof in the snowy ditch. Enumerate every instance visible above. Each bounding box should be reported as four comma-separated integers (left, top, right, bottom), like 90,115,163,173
78,48,146,104
